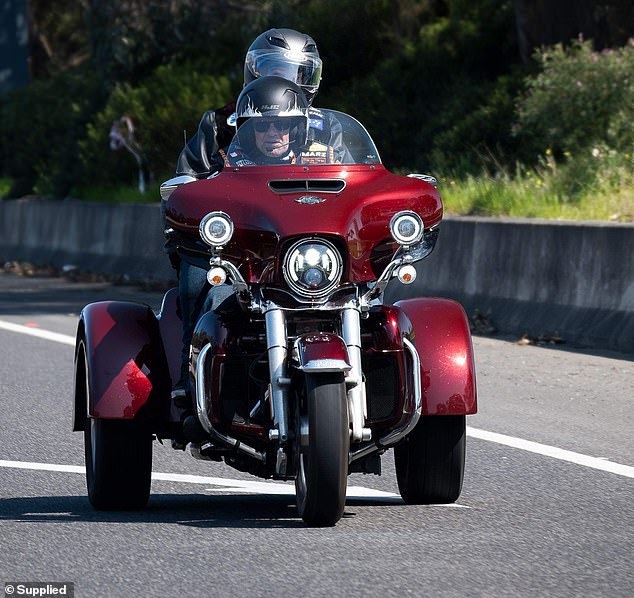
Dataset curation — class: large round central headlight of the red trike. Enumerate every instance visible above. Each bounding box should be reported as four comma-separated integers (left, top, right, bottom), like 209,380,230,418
284,239,343,297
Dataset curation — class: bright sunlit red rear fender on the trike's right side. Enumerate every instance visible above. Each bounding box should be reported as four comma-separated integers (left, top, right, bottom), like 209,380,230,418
395,297,478,415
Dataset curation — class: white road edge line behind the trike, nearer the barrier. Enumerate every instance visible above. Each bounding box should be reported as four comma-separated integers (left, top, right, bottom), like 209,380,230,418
0,320,634,482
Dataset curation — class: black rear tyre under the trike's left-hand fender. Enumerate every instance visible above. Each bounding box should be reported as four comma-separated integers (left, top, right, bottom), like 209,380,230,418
84,418,152,510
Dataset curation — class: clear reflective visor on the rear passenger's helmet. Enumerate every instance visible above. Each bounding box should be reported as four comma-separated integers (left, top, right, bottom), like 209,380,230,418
246,50,321,89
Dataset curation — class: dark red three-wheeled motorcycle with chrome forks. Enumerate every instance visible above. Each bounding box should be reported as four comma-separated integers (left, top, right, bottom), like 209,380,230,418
74,113,477,526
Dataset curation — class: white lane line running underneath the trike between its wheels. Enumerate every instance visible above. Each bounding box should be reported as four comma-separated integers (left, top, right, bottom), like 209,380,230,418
0,460,402,508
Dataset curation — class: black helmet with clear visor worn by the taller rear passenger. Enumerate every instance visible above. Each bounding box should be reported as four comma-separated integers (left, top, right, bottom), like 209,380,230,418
244,29,321,105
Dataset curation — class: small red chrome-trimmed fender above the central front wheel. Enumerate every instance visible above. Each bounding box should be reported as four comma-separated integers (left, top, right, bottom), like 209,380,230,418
295,332,352,374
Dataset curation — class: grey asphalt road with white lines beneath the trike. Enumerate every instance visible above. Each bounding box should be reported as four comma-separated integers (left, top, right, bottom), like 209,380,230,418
0,274,634,598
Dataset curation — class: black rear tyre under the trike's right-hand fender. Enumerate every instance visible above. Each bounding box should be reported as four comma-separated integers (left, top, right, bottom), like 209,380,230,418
394,415,466,505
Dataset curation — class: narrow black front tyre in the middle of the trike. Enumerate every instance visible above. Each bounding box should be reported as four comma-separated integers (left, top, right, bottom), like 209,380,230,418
295,374,350,527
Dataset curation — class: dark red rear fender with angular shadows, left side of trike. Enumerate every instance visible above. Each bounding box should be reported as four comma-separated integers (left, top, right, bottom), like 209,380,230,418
73,301,170,430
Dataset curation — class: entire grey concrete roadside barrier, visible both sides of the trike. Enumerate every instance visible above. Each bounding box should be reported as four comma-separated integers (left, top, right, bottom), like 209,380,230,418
0,200,634,352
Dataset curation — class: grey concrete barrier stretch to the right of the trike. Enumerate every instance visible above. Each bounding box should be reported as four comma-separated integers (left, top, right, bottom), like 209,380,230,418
382,217,634,352
